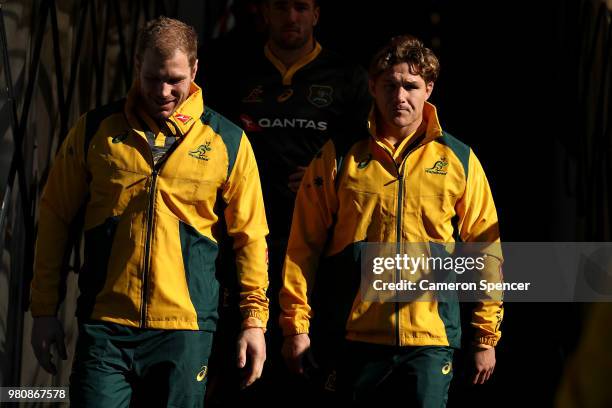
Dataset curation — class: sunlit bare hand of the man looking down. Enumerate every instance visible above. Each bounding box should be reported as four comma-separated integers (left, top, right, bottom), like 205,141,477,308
238,327,266,388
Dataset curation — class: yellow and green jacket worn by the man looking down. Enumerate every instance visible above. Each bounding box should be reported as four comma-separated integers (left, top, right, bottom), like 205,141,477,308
31,84,268,330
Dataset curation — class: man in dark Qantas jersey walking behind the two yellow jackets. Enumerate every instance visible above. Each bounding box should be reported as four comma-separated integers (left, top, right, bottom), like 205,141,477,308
207,0,371,404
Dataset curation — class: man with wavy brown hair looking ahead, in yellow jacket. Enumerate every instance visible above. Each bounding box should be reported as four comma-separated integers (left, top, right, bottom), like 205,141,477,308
280,36,503,407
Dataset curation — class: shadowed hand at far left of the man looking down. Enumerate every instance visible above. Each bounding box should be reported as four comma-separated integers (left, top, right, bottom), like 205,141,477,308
31,316,68,375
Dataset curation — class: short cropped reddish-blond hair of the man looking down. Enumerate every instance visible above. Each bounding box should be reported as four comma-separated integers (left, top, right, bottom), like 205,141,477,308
136,16,198,67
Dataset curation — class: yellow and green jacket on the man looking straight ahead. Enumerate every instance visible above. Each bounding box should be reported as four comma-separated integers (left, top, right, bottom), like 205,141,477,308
280,103,503,347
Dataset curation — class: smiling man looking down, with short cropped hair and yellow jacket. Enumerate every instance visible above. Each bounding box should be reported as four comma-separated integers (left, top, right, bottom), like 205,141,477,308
31,17,268,407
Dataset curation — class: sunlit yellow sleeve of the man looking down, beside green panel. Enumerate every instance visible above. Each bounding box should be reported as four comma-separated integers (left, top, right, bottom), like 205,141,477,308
223,133,268,328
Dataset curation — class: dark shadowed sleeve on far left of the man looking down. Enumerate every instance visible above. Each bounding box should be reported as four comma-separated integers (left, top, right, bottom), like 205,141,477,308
30,116,88,317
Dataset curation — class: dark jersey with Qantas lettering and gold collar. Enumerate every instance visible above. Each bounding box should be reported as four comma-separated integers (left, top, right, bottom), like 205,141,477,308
205,43,371,240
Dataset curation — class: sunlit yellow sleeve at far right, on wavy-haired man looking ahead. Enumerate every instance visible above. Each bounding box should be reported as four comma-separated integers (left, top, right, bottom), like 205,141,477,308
457,151,504,347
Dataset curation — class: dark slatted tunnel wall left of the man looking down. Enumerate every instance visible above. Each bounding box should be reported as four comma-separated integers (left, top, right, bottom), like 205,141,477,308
0,0,178,386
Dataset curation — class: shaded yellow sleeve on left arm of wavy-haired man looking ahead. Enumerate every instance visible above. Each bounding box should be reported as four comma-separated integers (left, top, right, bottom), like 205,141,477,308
280,141,338,336
